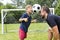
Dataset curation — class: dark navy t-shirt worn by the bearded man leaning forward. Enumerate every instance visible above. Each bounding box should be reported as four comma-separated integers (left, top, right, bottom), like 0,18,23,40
46,14,60,32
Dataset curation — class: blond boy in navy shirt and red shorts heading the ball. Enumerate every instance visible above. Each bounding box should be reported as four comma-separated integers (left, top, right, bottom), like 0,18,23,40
19,5,32,40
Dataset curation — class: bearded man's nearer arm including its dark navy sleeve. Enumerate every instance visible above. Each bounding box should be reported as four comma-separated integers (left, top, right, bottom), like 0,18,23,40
48,16,59,40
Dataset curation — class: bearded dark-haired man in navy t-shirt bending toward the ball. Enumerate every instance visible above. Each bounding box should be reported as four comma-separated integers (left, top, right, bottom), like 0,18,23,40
40,6,60,40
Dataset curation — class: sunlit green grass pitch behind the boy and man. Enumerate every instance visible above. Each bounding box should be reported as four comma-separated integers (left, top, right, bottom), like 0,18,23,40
0,23,48,40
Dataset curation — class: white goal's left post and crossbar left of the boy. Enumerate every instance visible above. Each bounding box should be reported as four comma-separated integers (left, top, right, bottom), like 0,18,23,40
1,9,25,34
